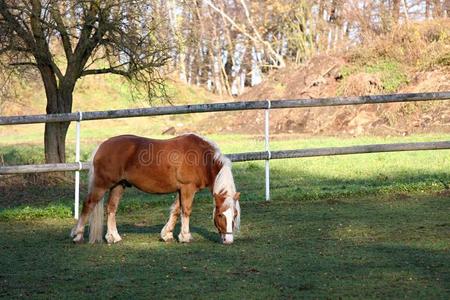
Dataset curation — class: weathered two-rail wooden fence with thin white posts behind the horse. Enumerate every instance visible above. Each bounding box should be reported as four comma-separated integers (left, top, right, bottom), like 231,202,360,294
0,91,450,217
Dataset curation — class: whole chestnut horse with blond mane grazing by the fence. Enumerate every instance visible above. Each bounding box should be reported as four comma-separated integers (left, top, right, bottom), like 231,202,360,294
70,133,241,244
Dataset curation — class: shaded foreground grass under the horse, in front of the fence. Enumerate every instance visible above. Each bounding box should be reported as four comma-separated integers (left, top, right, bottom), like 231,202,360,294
0,196,450,299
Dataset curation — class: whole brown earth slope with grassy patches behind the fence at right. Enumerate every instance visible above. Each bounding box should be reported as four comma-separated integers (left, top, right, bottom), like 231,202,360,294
199,19,450,135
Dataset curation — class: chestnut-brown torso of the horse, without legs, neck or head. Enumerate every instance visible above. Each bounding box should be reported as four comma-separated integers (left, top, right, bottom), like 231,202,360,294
93,134,214,193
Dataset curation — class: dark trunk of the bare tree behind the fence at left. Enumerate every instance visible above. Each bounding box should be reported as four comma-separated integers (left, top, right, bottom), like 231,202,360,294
39,66,74,163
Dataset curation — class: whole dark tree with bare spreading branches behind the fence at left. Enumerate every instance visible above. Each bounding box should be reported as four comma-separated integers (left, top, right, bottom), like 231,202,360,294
0,0,170,163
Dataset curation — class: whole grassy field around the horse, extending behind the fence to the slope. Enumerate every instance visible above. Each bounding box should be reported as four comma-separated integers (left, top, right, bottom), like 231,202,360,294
0,134,450,299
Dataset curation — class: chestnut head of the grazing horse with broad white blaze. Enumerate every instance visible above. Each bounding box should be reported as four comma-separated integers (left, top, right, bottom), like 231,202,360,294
214,191,241,244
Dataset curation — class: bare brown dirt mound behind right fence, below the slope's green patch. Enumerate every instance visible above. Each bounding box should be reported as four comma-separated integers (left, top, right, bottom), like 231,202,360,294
197,55,450,135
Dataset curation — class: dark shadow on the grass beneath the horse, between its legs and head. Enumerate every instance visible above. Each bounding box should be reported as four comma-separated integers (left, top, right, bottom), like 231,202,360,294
118,224,219,242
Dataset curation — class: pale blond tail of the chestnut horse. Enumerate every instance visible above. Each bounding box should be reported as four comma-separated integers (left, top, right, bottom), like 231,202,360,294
88,147,105,244
